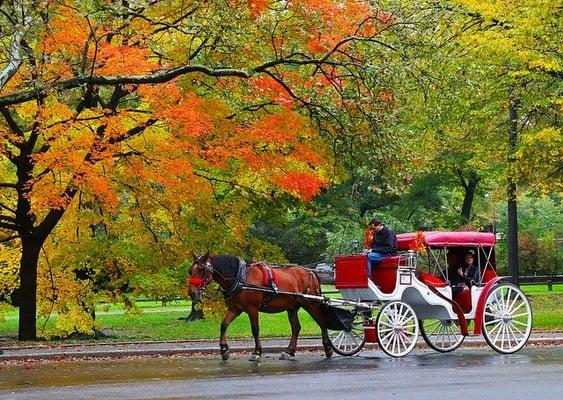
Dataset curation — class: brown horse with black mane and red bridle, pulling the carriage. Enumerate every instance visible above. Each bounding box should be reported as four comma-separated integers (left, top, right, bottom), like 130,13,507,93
188,252,332,361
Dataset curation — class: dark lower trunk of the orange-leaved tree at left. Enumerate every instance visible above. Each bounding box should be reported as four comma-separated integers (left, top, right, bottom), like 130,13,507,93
18,238,41,340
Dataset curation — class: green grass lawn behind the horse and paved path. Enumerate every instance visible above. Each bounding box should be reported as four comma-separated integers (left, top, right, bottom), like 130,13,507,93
0,284,563,343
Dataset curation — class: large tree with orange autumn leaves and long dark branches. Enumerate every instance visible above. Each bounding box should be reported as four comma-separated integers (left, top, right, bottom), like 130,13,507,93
0,0,432,339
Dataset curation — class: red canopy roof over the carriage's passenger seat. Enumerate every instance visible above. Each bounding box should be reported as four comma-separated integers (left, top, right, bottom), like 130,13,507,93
397,232,495,251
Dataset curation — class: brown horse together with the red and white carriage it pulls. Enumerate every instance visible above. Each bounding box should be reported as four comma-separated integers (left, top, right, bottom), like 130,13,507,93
188,232,532,361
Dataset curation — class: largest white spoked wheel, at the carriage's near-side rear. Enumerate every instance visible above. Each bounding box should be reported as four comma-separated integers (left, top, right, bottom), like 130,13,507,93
483,283,532,354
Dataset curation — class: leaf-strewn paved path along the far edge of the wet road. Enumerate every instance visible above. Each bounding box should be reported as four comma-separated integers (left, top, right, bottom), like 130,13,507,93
0,331,563,363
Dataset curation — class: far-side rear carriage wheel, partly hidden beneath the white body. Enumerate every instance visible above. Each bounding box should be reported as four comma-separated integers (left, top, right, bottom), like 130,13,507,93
418,319,465,353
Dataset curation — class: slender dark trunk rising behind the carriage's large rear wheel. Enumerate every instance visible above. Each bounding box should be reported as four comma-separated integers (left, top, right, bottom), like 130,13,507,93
507,96,520,285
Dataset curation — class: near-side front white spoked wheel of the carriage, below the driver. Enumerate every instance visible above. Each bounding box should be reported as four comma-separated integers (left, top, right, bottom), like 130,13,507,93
375,301,418,357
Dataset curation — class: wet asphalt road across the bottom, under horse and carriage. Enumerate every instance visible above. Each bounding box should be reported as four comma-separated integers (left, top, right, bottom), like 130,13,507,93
0,347,563,400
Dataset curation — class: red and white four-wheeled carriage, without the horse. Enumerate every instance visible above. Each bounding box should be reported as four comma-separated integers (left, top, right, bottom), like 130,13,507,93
325,232,532,357
